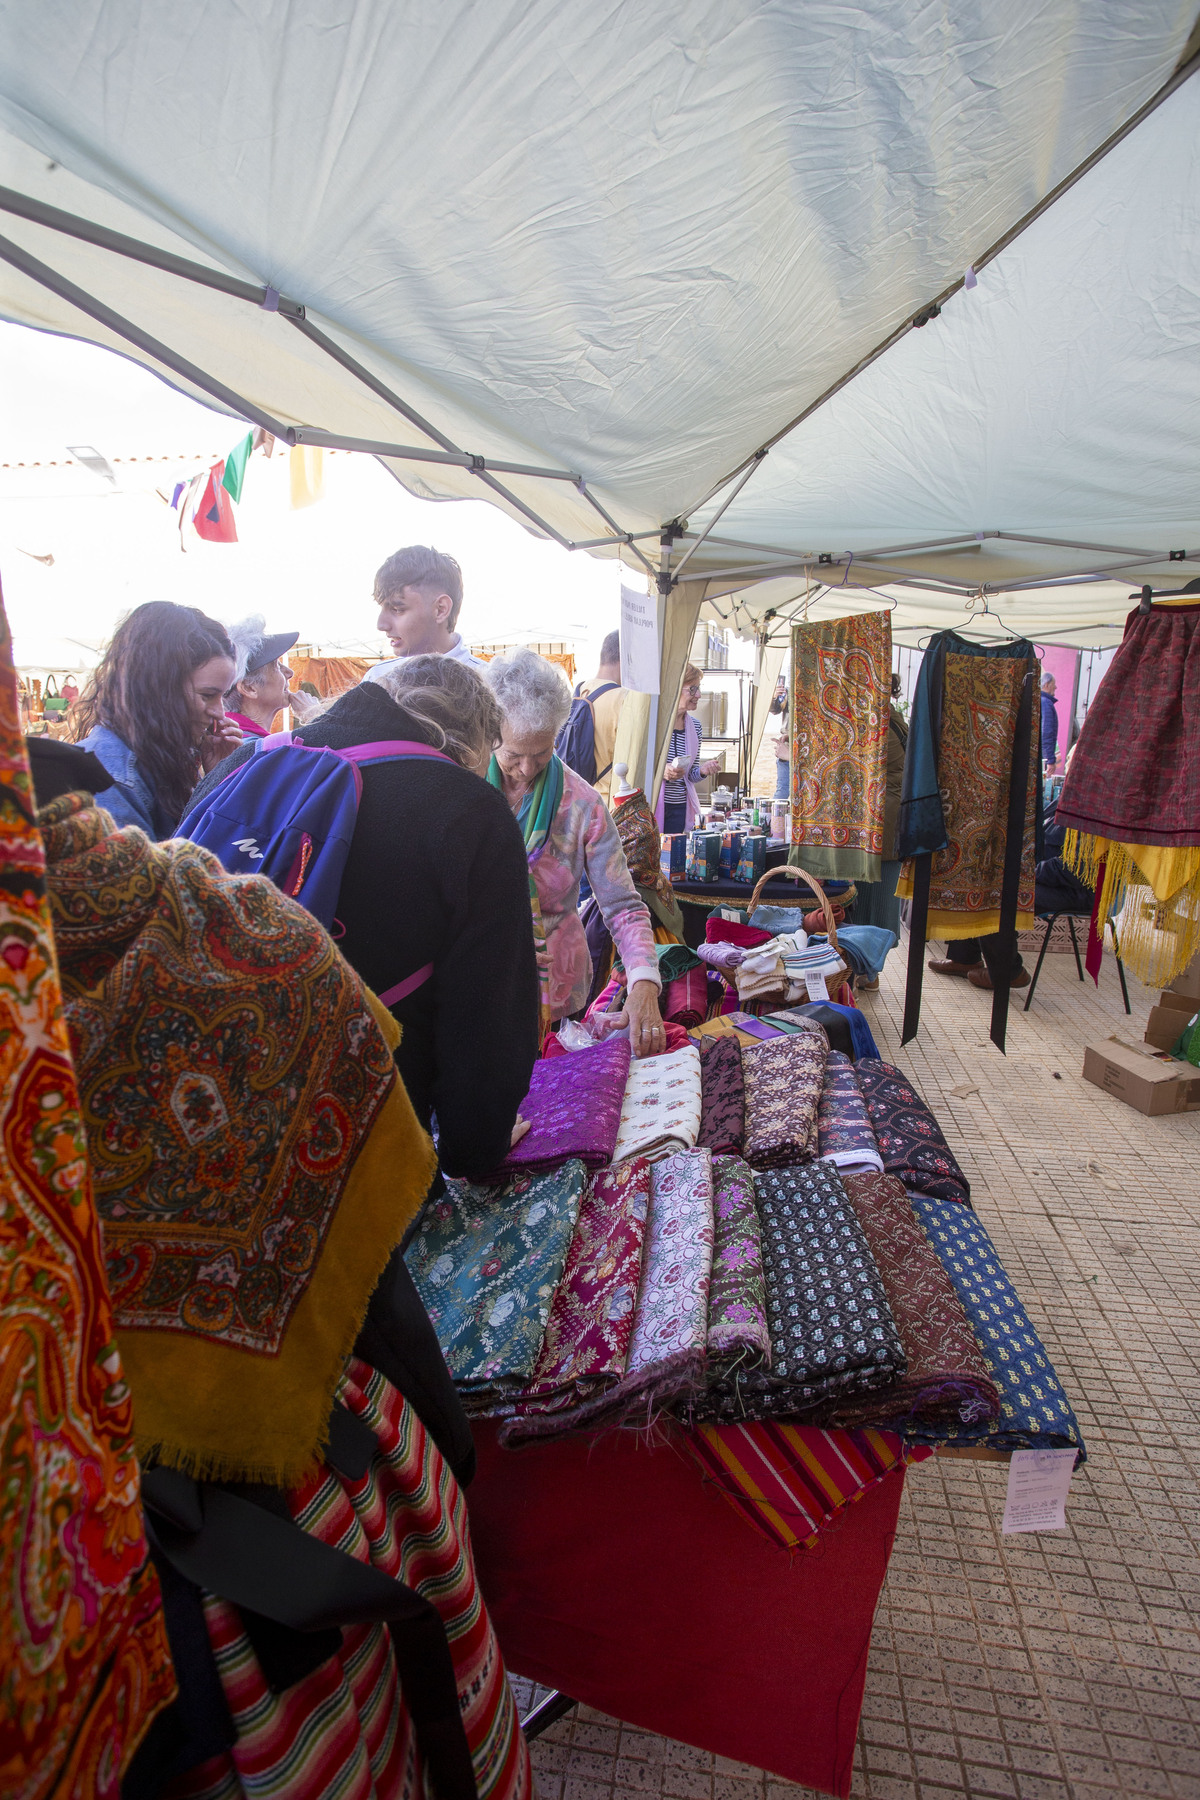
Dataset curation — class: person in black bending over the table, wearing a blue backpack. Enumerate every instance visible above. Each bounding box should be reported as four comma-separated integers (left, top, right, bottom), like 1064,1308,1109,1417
187,655,540,1181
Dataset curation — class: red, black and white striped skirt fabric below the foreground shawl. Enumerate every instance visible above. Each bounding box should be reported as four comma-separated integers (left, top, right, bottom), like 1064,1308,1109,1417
171,1359,533,1800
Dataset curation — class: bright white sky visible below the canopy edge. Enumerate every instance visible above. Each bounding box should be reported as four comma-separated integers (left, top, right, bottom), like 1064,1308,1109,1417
0,322,637,673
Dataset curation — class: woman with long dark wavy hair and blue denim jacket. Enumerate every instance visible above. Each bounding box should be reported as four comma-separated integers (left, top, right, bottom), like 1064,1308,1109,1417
72,599,241,839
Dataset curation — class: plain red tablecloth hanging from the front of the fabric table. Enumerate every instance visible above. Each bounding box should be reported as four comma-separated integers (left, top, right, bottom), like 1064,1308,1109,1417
468,1422,903,1795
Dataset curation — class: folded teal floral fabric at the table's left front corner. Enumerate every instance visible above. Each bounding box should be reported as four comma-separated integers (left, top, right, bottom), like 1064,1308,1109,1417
405,1159,587,1406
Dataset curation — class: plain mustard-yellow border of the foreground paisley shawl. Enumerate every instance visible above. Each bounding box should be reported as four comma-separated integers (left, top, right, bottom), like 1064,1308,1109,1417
125,1080,435,1487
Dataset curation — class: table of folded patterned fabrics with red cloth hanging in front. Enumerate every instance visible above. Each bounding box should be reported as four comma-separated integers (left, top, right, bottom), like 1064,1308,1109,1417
407,907,1083,1795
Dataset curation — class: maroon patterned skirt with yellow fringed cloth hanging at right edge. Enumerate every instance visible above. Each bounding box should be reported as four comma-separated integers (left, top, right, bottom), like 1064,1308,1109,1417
1056,590,1200,988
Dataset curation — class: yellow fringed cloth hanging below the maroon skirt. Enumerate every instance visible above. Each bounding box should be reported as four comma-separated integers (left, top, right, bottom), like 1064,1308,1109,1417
1063,830,1200,988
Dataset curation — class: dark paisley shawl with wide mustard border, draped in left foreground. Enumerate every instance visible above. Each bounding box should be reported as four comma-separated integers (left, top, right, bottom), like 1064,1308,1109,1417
40,794,434,1485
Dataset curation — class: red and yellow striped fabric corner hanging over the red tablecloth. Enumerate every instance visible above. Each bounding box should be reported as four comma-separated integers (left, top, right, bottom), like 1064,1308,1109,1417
684,1424,932,1550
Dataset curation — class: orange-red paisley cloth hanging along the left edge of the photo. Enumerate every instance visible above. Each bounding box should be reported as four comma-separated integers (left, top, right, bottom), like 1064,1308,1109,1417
0,594,175,1800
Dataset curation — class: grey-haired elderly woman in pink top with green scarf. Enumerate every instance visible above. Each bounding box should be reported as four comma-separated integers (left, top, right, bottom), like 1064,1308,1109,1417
486,650,666,1057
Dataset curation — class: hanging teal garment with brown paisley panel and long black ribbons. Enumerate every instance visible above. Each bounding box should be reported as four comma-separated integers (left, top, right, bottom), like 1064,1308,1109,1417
896,632,1042,1049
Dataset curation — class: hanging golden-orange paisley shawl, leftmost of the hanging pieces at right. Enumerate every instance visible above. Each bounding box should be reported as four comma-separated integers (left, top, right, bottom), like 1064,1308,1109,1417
790,612,892,882
